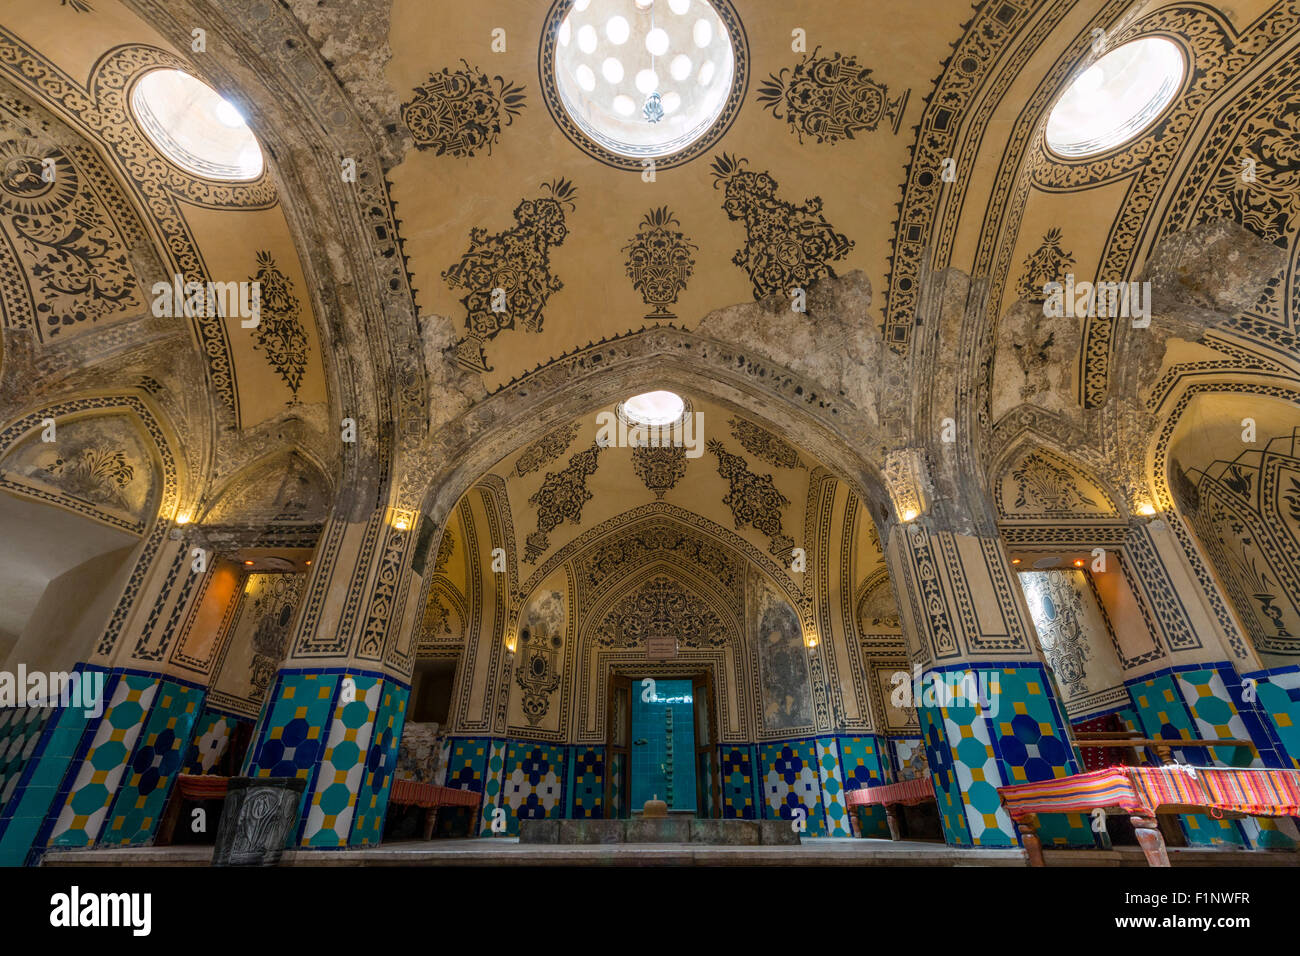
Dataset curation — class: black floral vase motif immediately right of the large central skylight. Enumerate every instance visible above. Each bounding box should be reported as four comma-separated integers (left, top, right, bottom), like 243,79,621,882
758,47,910,143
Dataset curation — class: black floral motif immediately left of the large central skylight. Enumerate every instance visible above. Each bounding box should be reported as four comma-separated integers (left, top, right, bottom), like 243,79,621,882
402,60,524,156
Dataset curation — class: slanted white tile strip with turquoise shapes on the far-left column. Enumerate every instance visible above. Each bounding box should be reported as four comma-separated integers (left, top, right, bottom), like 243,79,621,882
48,674,161,847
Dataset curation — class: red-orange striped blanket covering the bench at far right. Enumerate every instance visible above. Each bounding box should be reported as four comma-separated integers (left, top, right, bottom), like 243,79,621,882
997,766,1300,819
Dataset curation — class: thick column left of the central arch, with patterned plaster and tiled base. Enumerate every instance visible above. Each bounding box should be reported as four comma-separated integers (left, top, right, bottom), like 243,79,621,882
244,509,434,848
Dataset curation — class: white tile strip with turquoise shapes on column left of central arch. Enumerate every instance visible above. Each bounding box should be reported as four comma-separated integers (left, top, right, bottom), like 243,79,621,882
302,674,384,847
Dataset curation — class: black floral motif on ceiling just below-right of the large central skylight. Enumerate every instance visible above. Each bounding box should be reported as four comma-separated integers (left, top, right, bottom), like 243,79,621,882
712,153,853,299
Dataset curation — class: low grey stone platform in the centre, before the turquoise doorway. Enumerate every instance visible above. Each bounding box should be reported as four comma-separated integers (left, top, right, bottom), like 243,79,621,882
519,817,800,847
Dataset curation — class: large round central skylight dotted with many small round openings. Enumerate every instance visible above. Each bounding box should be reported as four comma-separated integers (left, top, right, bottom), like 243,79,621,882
542,0,744,168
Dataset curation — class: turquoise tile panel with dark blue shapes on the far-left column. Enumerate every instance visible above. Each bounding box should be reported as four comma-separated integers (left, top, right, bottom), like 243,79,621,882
100,680,205,845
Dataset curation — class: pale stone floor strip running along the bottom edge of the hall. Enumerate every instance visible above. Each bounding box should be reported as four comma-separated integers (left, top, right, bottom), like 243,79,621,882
44,838,1300,868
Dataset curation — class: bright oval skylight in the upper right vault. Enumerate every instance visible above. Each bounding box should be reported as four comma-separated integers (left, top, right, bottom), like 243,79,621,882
1047,36,1187,159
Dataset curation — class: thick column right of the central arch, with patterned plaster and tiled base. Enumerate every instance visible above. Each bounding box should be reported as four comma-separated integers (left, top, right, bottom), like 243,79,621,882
885,518,1093,847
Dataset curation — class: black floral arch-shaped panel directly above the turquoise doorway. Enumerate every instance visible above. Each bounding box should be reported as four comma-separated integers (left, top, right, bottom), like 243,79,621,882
594,575,727,648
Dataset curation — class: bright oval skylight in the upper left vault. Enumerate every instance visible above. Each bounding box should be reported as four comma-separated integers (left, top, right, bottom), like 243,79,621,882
131,70,263,179
